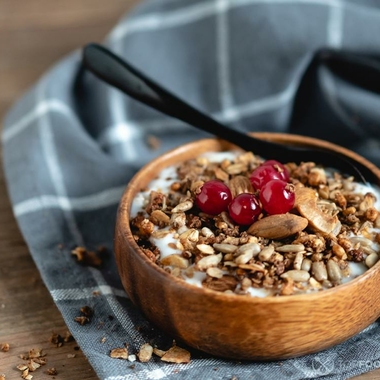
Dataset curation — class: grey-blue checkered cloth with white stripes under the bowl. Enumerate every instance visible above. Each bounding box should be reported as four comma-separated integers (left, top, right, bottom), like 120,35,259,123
2,0,380,380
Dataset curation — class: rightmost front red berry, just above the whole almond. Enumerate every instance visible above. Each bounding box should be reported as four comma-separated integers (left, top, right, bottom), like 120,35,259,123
260,179,295,215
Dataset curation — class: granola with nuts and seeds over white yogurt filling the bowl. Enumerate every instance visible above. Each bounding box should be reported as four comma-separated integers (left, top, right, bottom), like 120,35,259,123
130,151,380,297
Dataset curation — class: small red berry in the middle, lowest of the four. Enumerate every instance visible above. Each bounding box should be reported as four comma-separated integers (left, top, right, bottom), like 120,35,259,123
228,193,261,226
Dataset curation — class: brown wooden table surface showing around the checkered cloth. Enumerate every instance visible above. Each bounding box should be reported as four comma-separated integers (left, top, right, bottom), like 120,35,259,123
0,0,380,380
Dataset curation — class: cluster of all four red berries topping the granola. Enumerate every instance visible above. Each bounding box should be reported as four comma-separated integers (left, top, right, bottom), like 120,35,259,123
195,160,295,225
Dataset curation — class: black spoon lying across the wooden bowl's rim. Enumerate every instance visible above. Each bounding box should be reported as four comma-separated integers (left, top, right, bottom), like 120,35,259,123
83,44,379,184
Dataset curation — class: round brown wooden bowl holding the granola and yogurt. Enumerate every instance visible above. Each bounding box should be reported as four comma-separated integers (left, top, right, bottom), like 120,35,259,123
115,133,380,360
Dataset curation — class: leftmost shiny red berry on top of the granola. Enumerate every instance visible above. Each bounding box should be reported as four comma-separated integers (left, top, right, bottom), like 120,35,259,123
195,180,232,215
